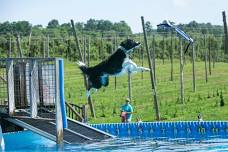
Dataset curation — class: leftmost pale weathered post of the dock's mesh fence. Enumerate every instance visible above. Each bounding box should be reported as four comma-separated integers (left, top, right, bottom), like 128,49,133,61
6,59,15,116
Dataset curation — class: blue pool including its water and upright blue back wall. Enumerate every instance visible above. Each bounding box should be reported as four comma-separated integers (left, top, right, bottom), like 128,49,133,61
3,122,228,152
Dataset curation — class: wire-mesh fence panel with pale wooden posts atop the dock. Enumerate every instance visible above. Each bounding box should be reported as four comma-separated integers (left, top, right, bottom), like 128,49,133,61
0,58,67,119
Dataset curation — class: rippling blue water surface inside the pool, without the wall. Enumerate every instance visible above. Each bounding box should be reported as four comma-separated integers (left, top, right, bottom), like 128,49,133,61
3,131,228,152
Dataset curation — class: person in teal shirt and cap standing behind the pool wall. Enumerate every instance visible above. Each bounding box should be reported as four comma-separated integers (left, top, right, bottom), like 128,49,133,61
121,98,133,122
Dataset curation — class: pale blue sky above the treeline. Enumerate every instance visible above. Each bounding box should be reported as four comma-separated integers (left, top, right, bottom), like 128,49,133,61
0,0,228,33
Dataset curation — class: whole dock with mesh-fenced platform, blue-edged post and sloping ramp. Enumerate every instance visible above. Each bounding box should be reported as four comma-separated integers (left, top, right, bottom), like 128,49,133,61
0,58,113,144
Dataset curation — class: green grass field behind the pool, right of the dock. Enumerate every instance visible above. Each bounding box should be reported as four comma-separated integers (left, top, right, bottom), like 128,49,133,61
65,59,228,123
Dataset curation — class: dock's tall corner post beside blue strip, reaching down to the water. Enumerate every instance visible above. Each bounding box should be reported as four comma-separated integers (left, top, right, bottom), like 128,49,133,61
55,60,63,144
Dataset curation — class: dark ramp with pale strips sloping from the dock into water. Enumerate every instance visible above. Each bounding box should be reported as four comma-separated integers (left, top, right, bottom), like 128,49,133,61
5,112,114,143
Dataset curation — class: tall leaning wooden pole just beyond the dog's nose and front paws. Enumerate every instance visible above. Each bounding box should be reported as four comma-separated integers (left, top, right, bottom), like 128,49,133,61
141,16,160,121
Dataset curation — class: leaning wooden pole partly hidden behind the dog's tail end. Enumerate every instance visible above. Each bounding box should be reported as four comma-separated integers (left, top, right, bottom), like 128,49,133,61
71,20,96,118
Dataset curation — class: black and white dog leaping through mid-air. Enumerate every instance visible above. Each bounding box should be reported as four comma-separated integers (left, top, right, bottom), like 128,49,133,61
78,39,150,97
